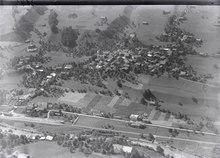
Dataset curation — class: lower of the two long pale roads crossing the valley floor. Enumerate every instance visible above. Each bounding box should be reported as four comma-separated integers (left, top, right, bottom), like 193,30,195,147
0,115,220,145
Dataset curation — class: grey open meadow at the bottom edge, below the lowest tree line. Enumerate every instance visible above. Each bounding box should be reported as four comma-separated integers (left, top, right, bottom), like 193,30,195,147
15,141,122,158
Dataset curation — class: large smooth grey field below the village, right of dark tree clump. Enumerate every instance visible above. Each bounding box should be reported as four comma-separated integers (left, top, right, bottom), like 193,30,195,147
136,76,219,119
